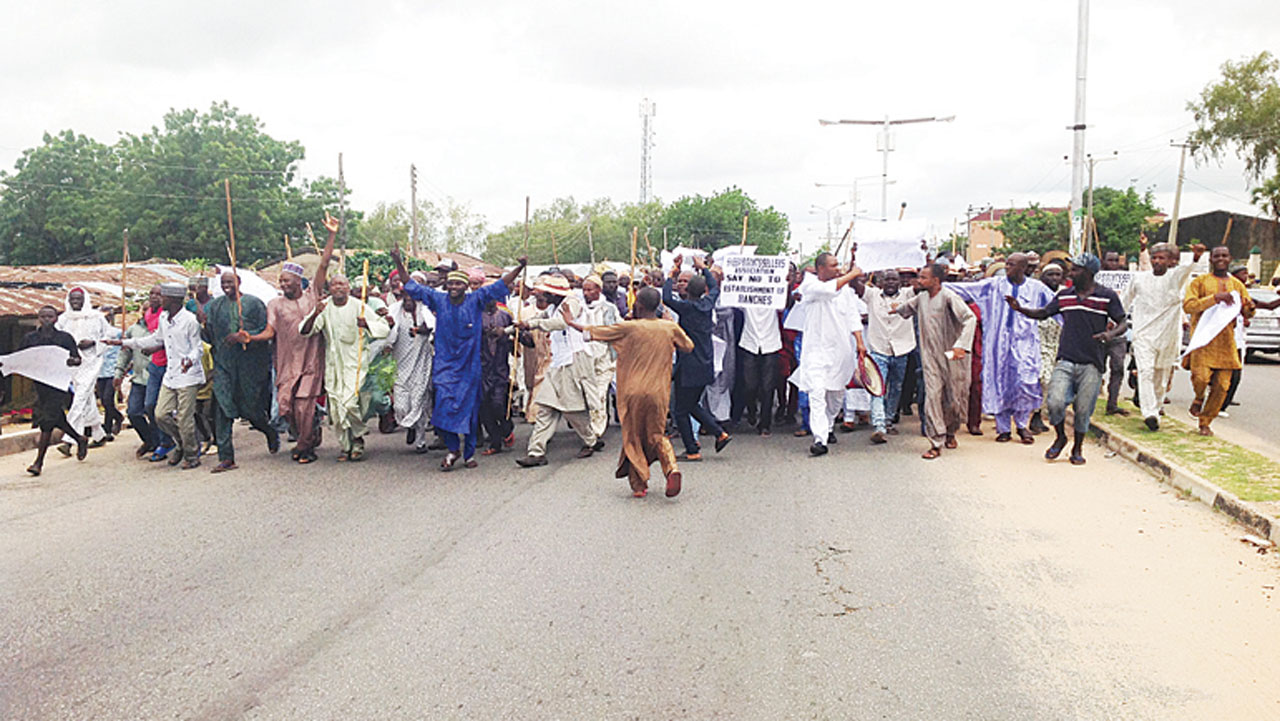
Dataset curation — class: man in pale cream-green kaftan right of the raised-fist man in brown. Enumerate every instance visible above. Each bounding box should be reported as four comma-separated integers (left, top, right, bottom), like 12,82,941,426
298,266,390,461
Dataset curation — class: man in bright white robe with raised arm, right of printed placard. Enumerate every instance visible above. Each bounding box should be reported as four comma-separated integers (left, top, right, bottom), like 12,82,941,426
788,252,867,456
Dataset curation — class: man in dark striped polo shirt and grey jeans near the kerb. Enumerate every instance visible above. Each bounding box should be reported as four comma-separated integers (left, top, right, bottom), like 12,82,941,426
1005,252,1128,466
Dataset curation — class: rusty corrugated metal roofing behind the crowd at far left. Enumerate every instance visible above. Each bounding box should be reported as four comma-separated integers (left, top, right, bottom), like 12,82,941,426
0,263,187,318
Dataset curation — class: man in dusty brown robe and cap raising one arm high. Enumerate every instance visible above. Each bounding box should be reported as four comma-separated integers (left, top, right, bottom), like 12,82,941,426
250,213,338,464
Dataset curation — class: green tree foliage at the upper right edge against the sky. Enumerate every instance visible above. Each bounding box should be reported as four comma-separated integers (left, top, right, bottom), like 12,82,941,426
1187,51,1280,216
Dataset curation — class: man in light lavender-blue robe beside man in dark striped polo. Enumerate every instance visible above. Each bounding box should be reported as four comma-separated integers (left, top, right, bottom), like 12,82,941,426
947,252,1053,443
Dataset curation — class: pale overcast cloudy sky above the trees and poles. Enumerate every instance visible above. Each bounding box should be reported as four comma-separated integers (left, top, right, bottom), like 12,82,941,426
0,0,1280,254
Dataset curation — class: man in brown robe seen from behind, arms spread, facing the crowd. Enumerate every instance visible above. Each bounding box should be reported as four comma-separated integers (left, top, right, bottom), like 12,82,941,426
567,288,694,498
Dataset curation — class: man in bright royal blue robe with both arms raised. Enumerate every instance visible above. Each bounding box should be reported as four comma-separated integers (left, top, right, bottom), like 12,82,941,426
390,247,529,471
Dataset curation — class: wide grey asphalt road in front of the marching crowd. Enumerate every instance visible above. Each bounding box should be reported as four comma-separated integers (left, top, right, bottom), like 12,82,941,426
0,426,1280,720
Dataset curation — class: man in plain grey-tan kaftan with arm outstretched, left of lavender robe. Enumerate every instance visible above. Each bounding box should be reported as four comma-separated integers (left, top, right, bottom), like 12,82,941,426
896,263,978,460
